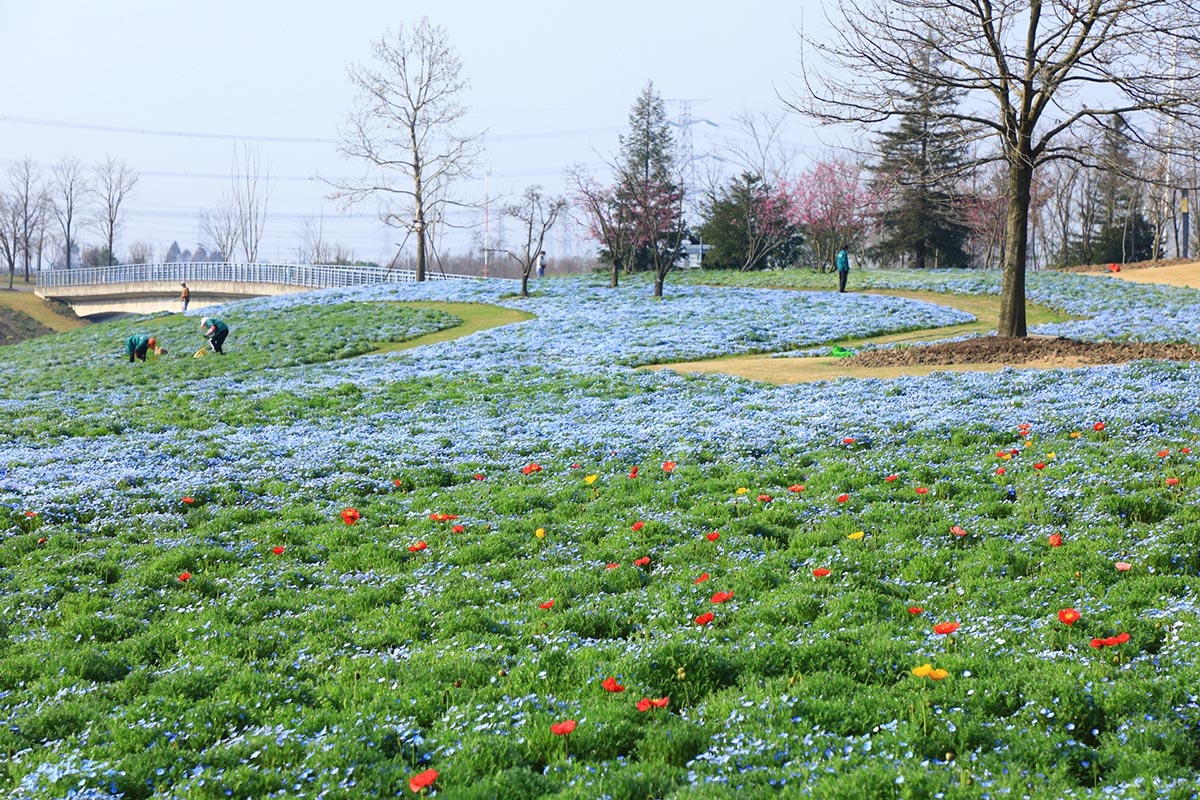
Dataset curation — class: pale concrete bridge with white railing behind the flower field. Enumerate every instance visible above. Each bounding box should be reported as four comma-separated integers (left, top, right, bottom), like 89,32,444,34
35,261,472,317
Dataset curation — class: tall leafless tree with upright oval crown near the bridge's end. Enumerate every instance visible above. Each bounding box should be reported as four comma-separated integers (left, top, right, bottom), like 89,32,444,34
334,18,482,281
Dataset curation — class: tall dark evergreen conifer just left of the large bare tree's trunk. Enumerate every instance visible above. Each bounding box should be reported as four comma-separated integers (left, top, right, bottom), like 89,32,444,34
871,50,970,269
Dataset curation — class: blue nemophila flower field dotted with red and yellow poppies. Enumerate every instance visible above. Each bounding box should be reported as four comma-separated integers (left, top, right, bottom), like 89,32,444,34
0,271,1200,798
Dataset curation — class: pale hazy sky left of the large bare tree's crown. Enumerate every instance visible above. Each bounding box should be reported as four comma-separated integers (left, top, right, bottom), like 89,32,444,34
0,0,835,267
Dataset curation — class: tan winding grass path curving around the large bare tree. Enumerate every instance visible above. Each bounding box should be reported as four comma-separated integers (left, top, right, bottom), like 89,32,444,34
646,289,1074,385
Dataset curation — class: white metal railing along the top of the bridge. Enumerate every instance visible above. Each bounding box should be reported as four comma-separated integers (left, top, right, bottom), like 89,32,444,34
37,261,475,289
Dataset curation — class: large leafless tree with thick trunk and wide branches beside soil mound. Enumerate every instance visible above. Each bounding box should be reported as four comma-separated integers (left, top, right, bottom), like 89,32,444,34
788,0,1200,336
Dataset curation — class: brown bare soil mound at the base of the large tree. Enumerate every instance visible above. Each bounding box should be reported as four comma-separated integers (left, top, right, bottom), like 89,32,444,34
848,336,1200,367
